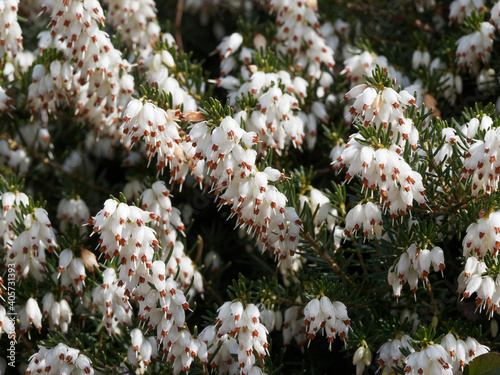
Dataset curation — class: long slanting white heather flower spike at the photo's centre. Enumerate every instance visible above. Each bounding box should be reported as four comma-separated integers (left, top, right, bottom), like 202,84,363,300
186,117,302,264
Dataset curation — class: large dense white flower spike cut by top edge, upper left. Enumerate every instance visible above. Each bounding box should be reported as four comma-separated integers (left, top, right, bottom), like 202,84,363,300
36,0,134,138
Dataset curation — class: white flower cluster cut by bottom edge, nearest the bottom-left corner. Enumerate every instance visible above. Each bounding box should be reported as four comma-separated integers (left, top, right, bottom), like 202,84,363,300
26,343,94,375
